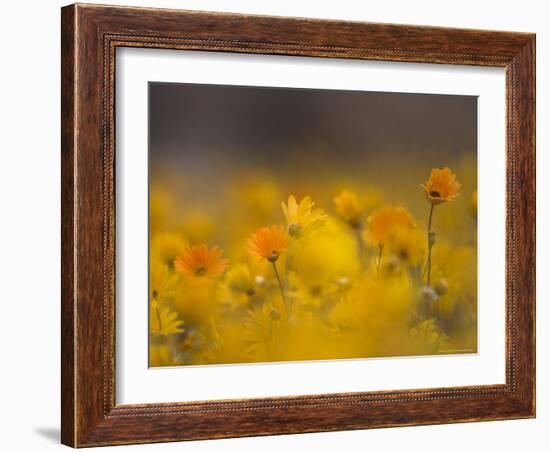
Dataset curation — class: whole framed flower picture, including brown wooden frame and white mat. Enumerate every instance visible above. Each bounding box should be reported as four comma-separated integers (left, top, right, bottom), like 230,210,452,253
61,4,535,447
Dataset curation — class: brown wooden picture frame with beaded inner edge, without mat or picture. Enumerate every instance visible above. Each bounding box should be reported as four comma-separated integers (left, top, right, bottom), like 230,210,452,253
61,4,535,447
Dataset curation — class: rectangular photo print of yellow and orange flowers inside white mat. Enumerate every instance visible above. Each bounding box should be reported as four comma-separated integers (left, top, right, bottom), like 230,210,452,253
148,82,478,367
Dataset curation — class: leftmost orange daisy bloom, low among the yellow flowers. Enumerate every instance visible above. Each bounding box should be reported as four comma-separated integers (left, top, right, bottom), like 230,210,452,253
174,244,227,278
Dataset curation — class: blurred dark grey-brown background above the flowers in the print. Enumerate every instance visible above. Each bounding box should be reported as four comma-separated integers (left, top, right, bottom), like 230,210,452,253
149,82,477,206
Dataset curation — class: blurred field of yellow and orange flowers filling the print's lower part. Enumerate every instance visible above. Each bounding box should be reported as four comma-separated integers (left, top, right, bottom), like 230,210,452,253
149,164,477,367
